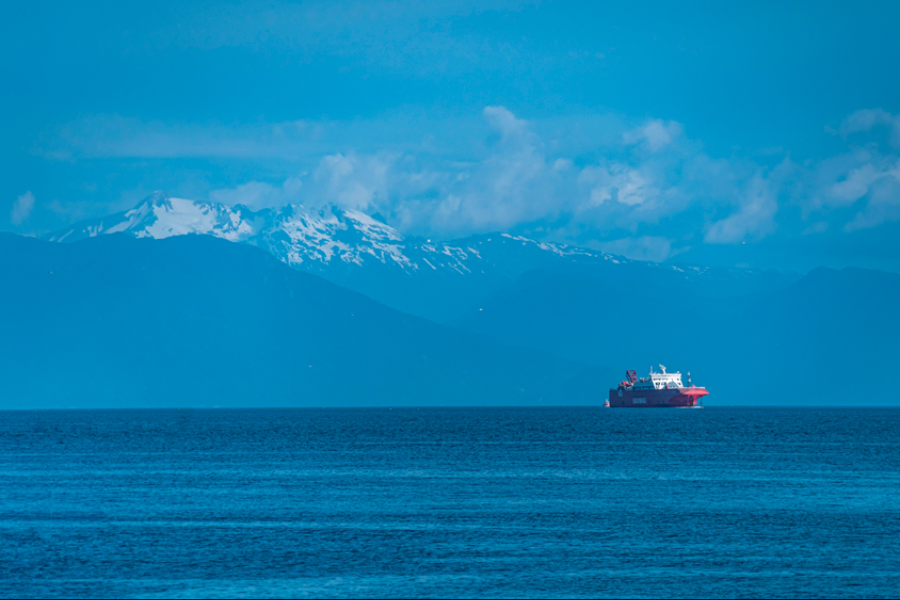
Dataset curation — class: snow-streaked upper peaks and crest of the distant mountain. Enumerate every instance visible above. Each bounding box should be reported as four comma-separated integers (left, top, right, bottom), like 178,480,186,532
45,192,627,274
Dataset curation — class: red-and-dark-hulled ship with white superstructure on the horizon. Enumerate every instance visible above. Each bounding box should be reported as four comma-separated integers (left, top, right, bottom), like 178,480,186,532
604,365,709,408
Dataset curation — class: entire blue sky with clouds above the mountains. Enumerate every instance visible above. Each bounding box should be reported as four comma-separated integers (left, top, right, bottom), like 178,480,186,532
0,0,900,272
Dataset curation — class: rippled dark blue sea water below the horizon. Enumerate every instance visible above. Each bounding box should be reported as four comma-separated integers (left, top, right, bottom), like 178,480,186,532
0,407,900,598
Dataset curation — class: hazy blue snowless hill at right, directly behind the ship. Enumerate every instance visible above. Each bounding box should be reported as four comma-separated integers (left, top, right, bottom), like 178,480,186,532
458,269,900,405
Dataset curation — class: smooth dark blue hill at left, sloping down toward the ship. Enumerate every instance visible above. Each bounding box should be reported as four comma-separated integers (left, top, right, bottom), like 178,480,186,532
0,234,607,408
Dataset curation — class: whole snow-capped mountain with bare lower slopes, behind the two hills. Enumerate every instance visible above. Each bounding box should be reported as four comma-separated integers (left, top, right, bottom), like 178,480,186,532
45,192,785,322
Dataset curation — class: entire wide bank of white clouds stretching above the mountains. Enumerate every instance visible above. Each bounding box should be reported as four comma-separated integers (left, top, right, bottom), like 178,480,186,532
33,106,900,260
